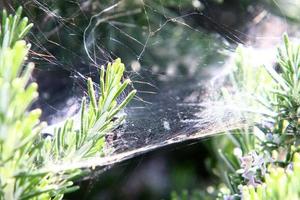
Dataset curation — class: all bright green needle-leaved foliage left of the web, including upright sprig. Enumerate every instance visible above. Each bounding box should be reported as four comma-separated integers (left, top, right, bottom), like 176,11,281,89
0,8,136,199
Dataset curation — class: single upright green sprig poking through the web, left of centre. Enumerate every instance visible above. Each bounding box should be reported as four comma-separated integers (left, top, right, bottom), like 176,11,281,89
41,59,136,164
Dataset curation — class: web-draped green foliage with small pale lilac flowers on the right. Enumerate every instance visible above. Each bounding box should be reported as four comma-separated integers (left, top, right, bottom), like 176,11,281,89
212,35,300,199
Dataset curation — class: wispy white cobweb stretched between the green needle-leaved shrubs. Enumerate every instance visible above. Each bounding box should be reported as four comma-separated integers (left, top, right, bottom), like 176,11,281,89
13,0,296,170
